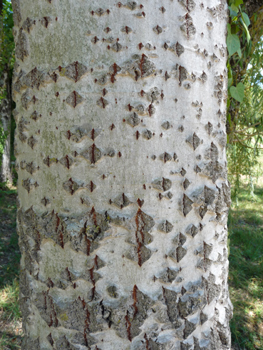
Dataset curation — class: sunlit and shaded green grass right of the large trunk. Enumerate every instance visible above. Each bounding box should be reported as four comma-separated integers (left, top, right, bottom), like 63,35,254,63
229,184,263,350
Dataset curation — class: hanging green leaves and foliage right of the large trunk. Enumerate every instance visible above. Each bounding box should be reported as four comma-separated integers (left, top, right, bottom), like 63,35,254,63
227,0,263,200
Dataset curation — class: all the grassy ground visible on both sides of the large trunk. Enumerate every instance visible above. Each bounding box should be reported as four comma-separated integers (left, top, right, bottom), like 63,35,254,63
0,183,263,350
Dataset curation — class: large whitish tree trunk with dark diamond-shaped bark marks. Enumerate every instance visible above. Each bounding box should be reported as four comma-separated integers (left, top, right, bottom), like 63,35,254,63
13,0,231,350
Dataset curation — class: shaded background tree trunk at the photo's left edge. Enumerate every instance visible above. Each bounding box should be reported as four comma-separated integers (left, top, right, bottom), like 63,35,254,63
0,68,12,183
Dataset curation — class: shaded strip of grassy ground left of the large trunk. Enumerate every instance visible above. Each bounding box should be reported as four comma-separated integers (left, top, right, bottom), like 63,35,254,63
0,187,22,350
